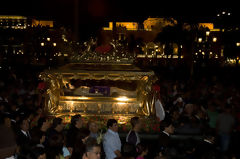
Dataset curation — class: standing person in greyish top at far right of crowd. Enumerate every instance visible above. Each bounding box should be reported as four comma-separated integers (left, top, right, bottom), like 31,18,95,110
216,106,234,152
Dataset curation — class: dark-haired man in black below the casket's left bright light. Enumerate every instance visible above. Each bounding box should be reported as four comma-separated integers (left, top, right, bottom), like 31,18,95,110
66,114,83,148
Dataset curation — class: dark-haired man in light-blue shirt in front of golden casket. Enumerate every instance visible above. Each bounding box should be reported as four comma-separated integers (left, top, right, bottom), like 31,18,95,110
103,119,122,159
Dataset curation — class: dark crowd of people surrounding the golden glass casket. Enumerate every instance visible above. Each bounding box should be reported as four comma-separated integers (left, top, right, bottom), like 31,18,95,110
0,65,240,159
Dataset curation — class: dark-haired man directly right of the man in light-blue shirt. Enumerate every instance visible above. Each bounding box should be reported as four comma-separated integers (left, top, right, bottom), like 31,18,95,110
126,117,141,145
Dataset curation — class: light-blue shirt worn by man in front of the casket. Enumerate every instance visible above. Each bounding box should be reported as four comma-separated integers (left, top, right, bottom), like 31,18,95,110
103,129,122,159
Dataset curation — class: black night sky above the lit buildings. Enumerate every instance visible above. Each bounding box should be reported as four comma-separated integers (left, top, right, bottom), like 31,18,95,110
0,0,240,36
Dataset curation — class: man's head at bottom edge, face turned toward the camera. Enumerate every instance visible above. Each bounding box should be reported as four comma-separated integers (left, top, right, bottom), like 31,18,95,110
83,137,101,159
